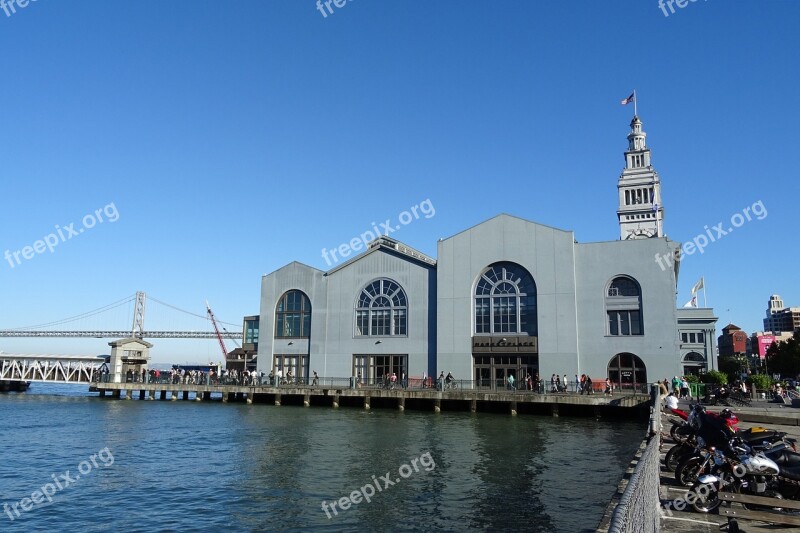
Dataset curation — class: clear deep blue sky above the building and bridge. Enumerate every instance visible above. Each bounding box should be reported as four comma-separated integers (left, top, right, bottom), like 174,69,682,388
0,0,800,362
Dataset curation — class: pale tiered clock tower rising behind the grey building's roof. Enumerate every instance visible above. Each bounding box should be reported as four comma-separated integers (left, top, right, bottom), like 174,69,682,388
617,115,664,240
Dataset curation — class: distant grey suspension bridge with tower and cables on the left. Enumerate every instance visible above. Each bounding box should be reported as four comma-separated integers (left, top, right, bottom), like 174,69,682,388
0,291,242,341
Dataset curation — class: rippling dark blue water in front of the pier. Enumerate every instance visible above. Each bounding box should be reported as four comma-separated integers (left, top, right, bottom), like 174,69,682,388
0,384,644,532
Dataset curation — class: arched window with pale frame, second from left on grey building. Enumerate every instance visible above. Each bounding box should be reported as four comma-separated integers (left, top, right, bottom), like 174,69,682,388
356,279,408,336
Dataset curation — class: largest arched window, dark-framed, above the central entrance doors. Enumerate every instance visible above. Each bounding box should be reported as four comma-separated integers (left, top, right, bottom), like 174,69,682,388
475,262,537,335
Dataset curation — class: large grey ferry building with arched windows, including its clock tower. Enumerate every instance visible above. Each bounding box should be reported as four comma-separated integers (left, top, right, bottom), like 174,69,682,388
258,116,716,388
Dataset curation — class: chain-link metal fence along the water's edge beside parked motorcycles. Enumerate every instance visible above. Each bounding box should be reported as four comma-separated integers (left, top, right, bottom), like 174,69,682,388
608,386,661,533
